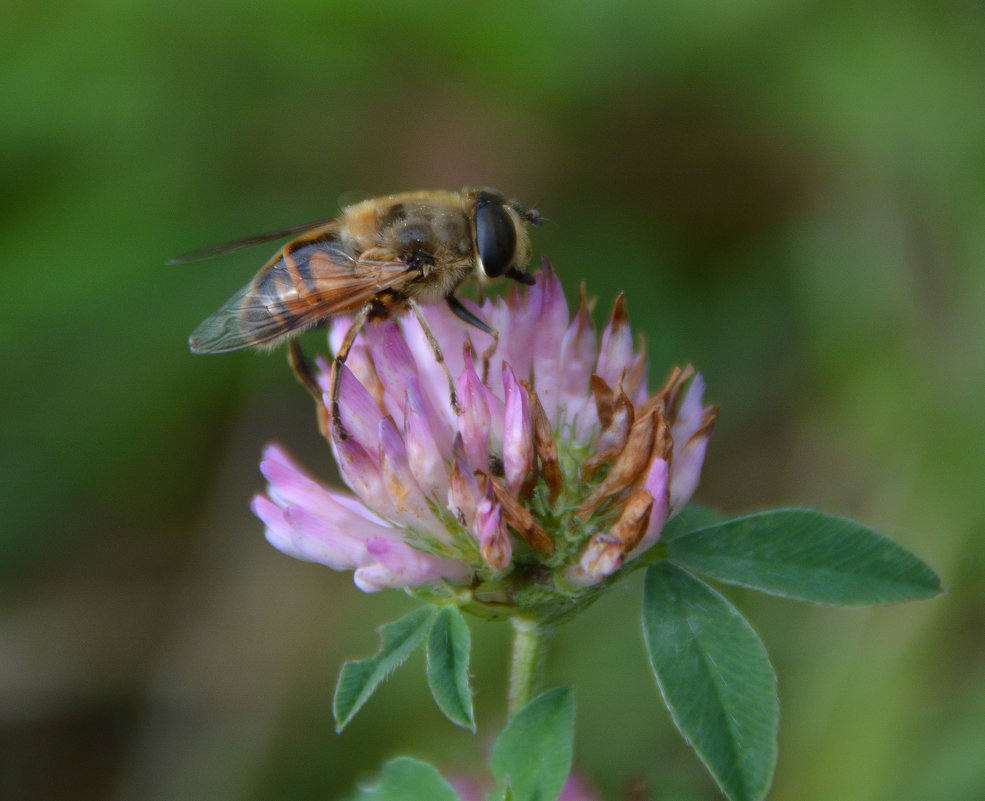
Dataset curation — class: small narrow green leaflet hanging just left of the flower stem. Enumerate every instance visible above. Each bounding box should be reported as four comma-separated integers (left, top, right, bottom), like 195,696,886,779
427,606,475,732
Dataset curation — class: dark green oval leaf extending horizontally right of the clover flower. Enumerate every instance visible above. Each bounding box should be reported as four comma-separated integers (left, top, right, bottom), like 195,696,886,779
668,509,941,606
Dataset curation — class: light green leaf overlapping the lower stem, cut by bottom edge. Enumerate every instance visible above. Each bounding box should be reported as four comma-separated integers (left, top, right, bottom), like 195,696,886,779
490,687,575,801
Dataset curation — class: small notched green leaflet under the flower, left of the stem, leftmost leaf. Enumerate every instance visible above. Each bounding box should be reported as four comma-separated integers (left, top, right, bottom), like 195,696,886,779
334,606,437,731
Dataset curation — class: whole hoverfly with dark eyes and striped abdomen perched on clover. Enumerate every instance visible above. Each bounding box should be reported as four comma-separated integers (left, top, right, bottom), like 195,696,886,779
176,188,540,439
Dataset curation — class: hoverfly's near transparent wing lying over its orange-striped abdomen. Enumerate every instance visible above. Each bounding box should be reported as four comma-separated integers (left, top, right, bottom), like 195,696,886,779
188,242,417,353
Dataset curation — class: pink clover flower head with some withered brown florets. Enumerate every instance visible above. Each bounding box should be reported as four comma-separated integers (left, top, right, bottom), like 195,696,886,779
252,261,718,614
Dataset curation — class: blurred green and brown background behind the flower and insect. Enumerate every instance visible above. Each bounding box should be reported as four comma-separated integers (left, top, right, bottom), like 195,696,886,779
0,0,985,801
